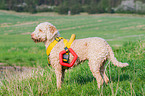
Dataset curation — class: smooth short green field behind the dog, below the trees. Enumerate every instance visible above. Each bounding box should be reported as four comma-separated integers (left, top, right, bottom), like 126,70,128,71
0,11,145,67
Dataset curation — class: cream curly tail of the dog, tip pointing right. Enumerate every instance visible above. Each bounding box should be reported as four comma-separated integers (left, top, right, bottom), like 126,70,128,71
108,44,129,67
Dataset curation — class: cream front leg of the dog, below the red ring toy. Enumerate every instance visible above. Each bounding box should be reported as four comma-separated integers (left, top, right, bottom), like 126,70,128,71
55,68,65,89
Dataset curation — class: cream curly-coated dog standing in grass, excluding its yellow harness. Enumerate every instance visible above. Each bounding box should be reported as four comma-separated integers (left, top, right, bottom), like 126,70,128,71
31,22,128,88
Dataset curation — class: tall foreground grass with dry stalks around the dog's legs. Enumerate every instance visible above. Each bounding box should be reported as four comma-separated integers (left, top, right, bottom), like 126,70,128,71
0,41,145,96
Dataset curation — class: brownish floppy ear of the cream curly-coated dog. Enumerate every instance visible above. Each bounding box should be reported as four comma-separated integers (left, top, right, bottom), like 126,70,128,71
46,25,57,40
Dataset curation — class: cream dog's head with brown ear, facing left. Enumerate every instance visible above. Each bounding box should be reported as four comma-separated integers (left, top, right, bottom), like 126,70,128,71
31,22,59,42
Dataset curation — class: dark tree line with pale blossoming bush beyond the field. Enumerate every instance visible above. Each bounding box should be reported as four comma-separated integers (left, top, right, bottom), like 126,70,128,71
0,0,145,14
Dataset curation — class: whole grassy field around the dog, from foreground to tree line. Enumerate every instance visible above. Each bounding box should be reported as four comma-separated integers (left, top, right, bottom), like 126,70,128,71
0,10,145,96
